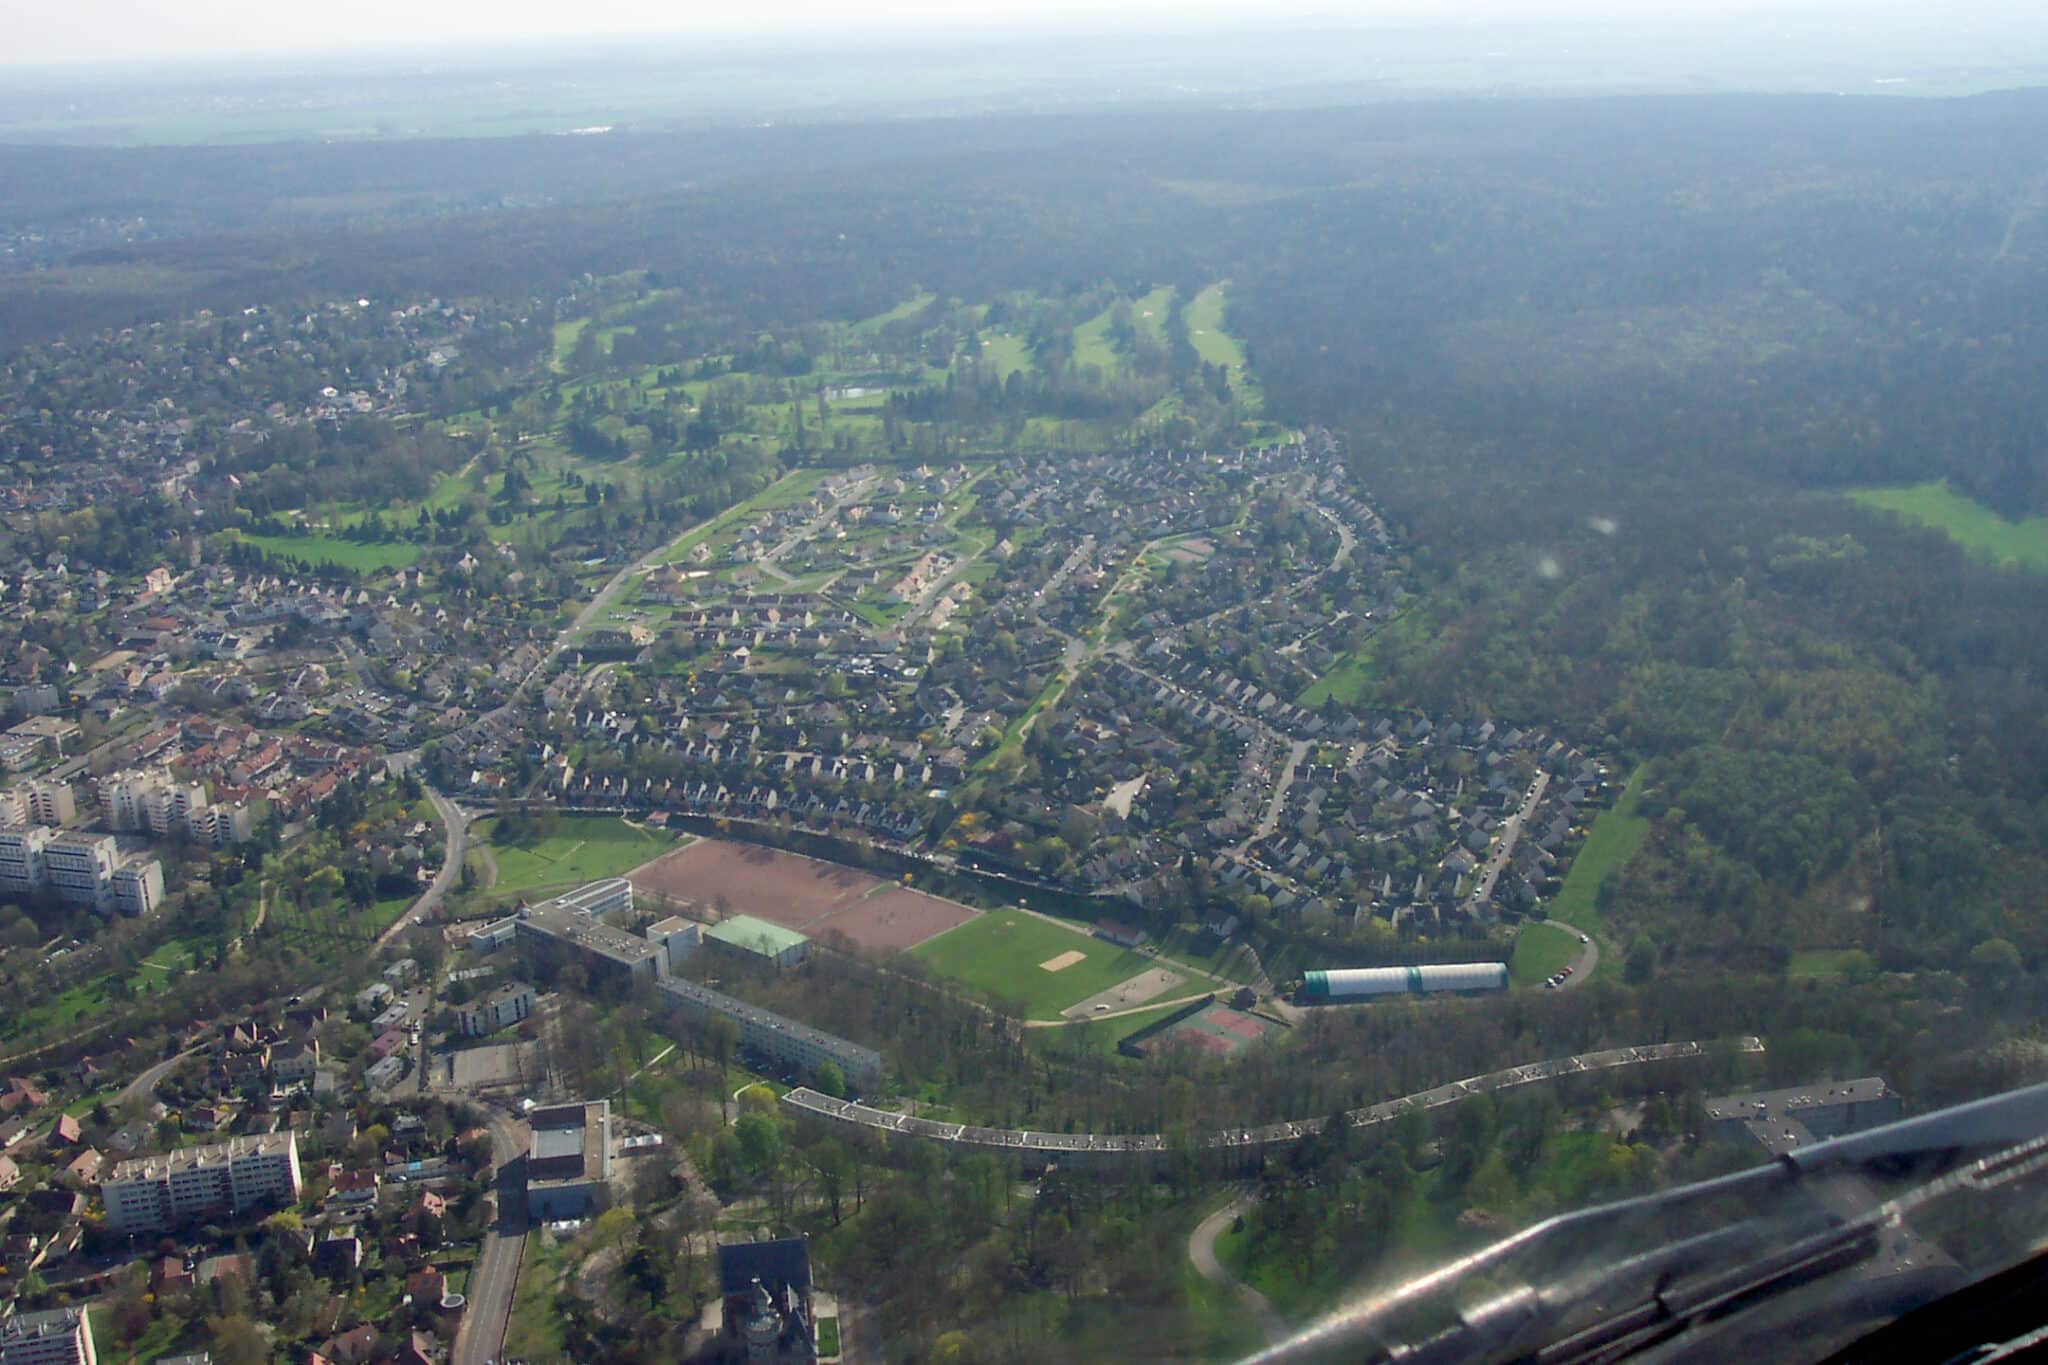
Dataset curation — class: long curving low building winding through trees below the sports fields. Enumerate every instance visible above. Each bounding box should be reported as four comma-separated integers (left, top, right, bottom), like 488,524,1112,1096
782,1038,1763,1169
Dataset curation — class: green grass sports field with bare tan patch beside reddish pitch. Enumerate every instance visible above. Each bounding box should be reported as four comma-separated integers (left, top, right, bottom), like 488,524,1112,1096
911,911,1155,1019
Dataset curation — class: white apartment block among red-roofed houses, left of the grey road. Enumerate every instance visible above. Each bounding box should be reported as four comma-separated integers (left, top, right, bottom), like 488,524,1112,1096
100,1132,303,1232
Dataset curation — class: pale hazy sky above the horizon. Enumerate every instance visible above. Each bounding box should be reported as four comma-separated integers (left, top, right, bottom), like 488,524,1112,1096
0,0,1974,65
